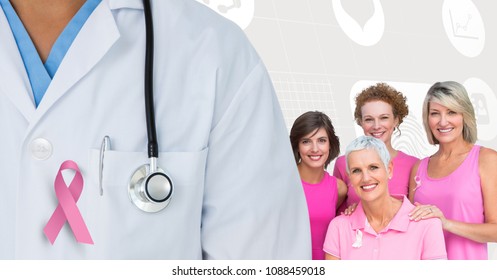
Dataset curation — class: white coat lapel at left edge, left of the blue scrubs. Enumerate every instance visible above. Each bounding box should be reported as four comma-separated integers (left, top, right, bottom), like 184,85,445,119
0,9,35,121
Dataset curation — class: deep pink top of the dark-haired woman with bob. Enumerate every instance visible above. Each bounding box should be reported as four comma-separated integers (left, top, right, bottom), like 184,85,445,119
302,171,338,260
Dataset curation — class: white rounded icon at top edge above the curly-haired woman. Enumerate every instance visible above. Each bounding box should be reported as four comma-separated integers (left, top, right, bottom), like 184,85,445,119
332,0,385,46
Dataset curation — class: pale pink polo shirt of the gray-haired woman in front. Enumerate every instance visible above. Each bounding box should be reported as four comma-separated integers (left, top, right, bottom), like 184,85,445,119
323,196,447,260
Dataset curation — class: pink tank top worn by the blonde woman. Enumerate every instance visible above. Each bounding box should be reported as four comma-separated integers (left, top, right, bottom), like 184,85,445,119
414,145,488,260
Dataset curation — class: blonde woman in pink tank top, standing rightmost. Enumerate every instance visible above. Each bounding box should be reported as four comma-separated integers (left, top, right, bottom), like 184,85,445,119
409,81,497,260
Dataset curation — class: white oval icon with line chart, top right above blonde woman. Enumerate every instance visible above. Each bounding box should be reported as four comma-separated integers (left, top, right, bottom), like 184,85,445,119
442,0,485,57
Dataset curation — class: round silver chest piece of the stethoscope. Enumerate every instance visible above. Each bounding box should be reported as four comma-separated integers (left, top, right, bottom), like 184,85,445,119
128,164,173,213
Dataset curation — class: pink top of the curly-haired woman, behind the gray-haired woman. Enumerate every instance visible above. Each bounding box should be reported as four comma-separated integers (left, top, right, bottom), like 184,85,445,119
333,151,419,214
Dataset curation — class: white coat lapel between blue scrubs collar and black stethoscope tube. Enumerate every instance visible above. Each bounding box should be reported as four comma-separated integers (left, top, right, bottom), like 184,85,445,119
32,1,120,121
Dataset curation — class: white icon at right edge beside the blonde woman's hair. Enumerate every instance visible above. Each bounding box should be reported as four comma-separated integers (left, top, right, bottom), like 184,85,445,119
464,78,497,141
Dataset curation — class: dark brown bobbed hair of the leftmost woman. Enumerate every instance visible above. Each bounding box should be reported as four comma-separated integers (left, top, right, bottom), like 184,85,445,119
290,111,340,168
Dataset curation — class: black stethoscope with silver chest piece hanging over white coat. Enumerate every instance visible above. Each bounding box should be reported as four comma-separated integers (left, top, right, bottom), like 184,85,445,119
128,0,173,213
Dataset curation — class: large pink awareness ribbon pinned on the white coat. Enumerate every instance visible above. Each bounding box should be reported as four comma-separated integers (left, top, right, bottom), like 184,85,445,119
43,160,93,245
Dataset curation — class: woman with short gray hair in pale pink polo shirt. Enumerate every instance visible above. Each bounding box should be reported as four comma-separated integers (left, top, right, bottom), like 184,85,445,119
323,136,447,260
